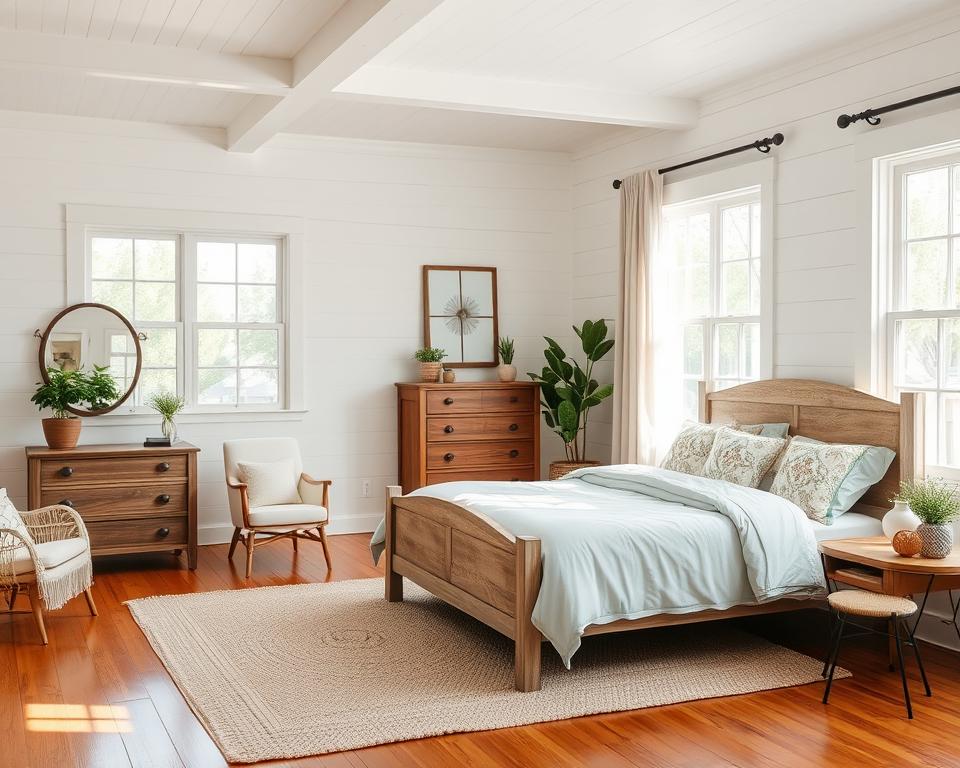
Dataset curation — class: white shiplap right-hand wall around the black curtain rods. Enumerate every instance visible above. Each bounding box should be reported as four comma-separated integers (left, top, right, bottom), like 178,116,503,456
572,11,960,458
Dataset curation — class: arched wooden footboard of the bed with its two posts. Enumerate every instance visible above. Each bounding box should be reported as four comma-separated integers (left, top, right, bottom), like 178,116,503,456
384,486,543,691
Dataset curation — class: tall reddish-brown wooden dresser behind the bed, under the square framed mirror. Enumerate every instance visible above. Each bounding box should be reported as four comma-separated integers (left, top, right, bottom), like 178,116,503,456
396,381,540,493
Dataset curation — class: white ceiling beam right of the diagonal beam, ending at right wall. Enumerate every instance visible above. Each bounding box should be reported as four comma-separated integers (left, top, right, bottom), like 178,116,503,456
334,64,700,128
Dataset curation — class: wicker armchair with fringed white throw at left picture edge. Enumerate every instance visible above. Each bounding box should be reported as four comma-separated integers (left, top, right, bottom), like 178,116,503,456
0,488,97,645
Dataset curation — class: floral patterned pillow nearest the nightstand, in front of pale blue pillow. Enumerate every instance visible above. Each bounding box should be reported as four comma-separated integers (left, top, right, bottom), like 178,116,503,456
770,437,866,525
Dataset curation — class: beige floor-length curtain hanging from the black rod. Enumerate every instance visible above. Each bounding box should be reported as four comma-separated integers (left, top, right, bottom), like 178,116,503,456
612,171,680,464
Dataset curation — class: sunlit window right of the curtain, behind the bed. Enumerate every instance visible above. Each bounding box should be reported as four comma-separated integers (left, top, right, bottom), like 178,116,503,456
661,188,762,418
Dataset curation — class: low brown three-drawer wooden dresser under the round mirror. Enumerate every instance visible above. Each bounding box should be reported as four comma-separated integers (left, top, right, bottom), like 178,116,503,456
27,442,200,569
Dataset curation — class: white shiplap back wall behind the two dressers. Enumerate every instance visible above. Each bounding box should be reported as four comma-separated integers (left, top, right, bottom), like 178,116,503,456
0,113,570,542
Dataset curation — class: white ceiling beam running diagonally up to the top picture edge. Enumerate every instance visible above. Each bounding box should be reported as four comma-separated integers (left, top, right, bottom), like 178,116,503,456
227,0,442,152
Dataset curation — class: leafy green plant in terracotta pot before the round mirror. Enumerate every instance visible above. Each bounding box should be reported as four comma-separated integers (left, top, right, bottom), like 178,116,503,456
30,366,120,449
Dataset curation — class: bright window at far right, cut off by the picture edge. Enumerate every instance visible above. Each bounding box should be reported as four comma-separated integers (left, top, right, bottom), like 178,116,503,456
886,154,960,468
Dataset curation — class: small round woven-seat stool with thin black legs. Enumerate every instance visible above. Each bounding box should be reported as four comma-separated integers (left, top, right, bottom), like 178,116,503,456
823,589,931,719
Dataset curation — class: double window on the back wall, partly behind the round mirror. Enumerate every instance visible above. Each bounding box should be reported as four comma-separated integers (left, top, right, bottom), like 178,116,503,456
85,232,286,410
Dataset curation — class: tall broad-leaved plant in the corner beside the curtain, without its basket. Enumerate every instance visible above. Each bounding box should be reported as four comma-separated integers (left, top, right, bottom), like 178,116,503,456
527,319,613,461
